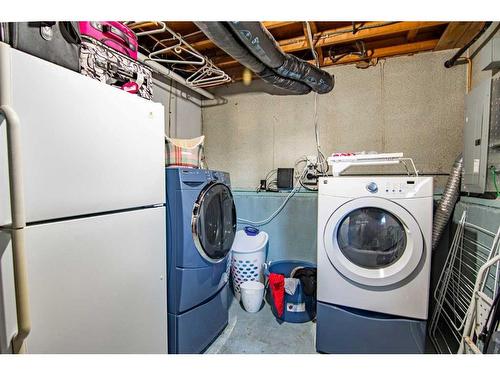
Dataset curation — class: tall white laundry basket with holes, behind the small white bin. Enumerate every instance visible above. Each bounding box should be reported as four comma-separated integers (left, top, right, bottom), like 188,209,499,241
231,227,269,301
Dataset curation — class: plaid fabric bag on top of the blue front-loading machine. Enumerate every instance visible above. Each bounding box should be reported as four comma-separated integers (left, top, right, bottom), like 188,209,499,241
165,135,205,168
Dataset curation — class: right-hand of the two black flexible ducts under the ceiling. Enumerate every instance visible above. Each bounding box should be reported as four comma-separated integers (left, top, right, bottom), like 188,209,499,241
228,21,335,94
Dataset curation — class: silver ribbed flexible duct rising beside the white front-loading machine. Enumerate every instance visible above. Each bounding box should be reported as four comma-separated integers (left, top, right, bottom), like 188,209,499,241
432,154,463,250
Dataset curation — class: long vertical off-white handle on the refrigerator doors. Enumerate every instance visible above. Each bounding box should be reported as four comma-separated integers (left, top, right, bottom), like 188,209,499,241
0,104,31,354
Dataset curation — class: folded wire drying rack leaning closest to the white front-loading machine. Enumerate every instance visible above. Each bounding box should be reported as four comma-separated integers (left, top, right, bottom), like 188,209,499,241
429,211,500,353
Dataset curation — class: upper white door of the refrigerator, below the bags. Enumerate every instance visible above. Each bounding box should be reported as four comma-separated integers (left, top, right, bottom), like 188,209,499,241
0,48,165,226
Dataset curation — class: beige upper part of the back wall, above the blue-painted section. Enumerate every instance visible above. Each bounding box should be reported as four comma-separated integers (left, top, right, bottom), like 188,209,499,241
202,51,465,188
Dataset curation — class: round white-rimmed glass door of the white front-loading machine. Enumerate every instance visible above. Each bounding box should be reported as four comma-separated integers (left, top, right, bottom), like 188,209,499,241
323,197,424,287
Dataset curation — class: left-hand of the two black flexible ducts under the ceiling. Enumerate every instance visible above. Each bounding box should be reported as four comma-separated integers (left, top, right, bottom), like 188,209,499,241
195,21,311,95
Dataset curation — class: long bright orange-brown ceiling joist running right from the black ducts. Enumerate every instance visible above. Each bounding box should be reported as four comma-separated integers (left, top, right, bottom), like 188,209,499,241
279,22,448,53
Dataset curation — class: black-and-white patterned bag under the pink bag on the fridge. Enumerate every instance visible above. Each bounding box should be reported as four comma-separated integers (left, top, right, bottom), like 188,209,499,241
80,36,153,100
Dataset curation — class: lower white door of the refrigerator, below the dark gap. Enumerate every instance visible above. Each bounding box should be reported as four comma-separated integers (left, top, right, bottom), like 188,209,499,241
0,207,167,353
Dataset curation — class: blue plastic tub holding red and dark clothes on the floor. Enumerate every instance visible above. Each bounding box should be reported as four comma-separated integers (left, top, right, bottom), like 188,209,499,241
265,260,316,323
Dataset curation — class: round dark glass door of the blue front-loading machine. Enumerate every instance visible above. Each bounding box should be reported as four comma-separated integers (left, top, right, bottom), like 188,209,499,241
191,183,236,263
